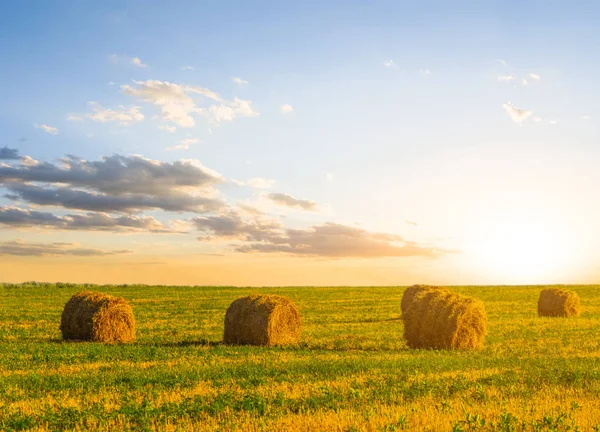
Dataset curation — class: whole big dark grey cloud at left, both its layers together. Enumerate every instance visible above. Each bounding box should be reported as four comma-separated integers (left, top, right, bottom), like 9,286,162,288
0,155,223,213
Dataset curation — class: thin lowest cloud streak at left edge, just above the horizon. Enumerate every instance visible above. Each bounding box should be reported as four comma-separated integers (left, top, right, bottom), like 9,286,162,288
0,240,131,257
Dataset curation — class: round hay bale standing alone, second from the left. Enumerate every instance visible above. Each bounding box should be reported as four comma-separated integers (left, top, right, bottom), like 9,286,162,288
223,294,302,346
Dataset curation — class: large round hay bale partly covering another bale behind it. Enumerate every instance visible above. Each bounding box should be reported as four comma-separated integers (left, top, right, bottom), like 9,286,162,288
402,289,487,350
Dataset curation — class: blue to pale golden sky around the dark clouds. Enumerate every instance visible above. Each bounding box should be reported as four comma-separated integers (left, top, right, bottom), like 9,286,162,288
0,1,600,283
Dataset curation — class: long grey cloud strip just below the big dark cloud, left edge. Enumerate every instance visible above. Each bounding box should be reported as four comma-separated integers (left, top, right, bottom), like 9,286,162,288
0,207,179,233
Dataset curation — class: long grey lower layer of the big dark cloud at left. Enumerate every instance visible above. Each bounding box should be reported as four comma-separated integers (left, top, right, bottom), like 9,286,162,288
4,183,224,213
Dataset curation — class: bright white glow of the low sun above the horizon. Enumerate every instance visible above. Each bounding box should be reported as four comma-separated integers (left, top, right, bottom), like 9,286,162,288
470,211,576,283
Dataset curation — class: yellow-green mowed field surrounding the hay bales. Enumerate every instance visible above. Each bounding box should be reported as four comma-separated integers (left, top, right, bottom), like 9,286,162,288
0,285,600,431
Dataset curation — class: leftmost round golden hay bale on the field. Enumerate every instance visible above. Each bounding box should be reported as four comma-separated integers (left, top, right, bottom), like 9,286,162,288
60,291,135,343
